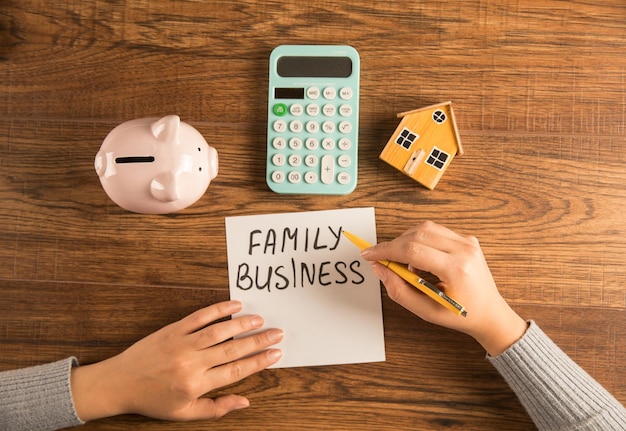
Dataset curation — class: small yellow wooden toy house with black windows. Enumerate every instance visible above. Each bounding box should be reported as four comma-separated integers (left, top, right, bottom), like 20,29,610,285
380,102,463,190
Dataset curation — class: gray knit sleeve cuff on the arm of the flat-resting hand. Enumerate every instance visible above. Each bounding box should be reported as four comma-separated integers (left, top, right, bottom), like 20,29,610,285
0,358,83,431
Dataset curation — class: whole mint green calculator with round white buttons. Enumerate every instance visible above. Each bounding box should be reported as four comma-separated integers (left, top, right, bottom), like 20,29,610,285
266,45,360,195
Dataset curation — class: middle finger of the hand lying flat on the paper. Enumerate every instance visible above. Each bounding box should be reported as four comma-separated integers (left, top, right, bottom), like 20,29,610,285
205,329,283,367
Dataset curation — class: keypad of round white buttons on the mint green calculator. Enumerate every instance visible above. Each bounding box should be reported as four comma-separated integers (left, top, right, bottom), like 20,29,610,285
267,85,358,194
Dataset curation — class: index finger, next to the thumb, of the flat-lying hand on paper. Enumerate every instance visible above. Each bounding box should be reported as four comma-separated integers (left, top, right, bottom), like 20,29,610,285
206,349,282,392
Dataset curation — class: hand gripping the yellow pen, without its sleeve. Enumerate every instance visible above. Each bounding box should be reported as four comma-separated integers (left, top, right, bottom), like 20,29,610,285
361,221,527,356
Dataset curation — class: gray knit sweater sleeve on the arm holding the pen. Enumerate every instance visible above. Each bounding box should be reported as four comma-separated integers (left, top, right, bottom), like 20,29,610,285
487,321,626,431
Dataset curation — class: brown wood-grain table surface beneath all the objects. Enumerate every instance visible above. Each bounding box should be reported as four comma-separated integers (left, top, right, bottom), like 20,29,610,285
0,0,626,431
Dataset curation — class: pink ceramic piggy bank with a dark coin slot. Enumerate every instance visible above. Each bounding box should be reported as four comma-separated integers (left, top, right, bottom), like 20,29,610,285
94,115,218,214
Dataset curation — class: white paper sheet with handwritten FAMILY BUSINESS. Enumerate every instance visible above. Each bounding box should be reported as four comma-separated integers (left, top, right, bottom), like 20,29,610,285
226,208,385,368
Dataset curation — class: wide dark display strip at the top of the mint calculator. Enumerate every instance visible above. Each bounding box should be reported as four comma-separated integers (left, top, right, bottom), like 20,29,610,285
276,56,352,78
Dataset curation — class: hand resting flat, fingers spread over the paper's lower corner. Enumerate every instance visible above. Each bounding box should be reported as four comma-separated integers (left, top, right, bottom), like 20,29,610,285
71,301,283,421
